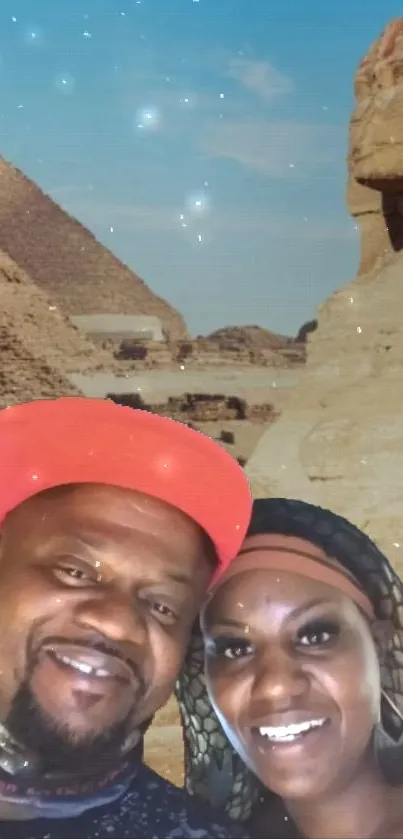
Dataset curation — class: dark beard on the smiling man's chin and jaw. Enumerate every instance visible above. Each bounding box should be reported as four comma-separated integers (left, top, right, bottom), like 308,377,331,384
4,680,132,775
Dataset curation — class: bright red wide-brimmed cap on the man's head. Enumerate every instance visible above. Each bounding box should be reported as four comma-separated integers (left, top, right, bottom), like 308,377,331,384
0,397,252,575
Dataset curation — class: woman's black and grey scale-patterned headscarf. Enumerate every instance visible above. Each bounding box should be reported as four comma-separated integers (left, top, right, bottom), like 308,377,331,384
176,498,403,821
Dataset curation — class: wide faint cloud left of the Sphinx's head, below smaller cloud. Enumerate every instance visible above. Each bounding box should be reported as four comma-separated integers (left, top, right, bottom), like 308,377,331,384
201,120,343,178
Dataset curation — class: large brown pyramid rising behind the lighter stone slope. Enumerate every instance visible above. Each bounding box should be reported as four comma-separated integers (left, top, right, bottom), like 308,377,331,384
0,158,187,338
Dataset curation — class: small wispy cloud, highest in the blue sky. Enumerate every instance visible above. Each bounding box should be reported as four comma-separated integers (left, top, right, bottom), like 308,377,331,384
228,58,295,102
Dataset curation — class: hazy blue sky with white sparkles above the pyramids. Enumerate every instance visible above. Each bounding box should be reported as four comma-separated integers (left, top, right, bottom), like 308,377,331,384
0,0,402,334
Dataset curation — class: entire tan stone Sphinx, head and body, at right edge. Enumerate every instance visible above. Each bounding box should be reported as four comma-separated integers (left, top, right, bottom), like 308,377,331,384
247,19,403,571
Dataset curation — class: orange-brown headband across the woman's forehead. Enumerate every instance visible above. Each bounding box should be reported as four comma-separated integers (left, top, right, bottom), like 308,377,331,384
219,545,374,618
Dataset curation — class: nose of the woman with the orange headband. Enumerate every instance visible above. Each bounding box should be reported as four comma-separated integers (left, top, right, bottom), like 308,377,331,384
252,651,309,710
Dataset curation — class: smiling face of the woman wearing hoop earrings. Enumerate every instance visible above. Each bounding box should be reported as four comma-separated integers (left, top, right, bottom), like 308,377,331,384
203,534,380,799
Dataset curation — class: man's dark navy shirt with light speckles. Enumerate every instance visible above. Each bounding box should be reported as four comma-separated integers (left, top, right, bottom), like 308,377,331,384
0,766,245,839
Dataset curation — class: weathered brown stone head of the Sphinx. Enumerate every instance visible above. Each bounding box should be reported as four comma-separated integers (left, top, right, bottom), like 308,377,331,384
347,18,403,273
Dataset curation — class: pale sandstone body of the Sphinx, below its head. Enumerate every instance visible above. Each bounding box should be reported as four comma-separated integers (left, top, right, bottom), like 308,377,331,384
247,254,403,571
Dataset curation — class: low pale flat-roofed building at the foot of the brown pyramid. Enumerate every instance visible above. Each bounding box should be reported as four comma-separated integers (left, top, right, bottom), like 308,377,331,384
70,315,164,341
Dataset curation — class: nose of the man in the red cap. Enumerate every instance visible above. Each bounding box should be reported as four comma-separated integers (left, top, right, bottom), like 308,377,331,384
76,589,147,646
